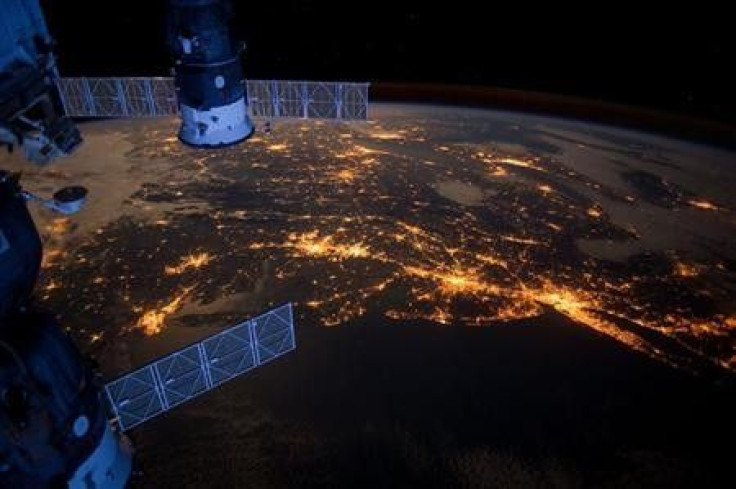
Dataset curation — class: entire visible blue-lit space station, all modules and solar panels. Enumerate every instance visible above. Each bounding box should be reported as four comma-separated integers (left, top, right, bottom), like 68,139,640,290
0,0,322,482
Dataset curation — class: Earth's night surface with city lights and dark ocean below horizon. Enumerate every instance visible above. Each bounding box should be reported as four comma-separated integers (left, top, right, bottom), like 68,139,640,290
0,104,736,488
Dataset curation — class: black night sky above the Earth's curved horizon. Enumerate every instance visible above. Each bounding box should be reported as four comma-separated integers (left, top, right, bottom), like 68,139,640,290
42,0,736,122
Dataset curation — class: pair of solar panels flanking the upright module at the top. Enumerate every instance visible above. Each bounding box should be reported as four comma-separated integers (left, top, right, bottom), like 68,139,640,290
58,78,369,120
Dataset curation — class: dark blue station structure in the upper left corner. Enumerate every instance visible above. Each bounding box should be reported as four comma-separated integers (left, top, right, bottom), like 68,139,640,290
0,0,82,163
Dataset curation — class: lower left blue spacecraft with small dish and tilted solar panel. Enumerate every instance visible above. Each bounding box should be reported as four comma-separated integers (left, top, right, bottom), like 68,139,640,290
0,170,296,489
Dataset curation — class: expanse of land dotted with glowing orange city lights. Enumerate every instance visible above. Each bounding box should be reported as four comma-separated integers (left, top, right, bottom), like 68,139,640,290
30,112,736,370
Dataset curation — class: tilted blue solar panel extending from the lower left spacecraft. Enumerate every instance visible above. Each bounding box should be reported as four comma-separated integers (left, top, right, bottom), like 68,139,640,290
105,304,296,430
